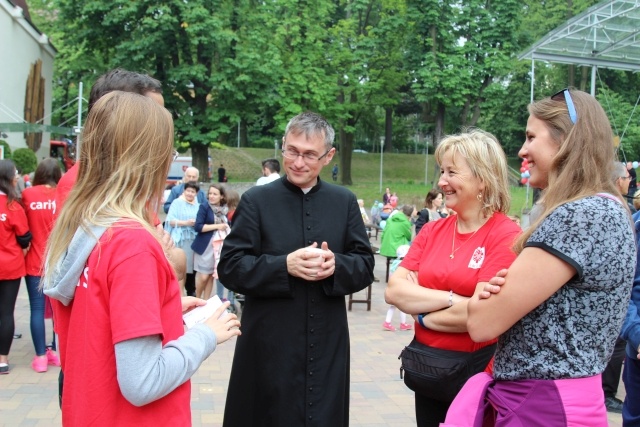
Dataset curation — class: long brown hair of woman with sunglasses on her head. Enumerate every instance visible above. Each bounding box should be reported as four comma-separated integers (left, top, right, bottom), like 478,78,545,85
514,89,619,253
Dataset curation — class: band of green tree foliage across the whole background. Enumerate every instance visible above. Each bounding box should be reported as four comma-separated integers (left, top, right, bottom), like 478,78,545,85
30,0,640,184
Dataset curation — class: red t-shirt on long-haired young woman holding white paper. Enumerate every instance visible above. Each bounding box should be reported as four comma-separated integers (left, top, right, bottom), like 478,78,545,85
52,226,191,426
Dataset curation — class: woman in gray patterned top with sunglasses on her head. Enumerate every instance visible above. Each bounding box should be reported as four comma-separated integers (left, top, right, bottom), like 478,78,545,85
450,89,636,426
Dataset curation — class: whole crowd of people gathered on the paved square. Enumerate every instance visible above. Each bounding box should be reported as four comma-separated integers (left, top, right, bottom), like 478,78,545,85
0,69,640,426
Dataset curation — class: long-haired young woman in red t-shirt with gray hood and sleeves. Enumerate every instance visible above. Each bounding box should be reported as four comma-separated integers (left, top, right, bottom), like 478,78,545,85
43,91,240,425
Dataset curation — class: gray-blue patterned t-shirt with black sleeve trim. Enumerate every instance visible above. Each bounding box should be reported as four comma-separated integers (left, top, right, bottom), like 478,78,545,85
494,196,636,380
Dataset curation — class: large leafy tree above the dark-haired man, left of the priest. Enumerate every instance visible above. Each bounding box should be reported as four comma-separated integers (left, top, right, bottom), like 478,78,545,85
48,0,282,176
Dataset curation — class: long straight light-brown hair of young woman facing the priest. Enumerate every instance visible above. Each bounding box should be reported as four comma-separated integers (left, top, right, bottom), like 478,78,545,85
45,91,173,283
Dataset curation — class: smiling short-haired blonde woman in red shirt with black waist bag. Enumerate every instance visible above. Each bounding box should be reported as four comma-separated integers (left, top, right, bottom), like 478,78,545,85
385,129,520,427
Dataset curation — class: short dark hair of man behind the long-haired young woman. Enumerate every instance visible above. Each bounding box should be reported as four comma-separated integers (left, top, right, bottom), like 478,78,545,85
89,68,162,111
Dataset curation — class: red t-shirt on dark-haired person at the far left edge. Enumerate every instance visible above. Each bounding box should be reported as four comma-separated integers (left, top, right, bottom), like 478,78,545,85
0,191,29,280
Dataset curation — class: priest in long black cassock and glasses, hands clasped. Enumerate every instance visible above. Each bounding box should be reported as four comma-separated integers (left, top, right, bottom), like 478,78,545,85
218,112,374,427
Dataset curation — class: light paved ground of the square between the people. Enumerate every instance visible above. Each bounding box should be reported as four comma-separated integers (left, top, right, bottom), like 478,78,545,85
0,252,624,427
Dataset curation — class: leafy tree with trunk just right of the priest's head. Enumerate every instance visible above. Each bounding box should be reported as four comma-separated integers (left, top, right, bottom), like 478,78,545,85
330,0,408,185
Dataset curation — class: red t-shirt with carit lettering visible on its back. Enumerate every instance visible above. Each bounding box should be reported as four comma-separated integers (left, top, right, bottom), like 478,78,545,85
22,185,56,276
